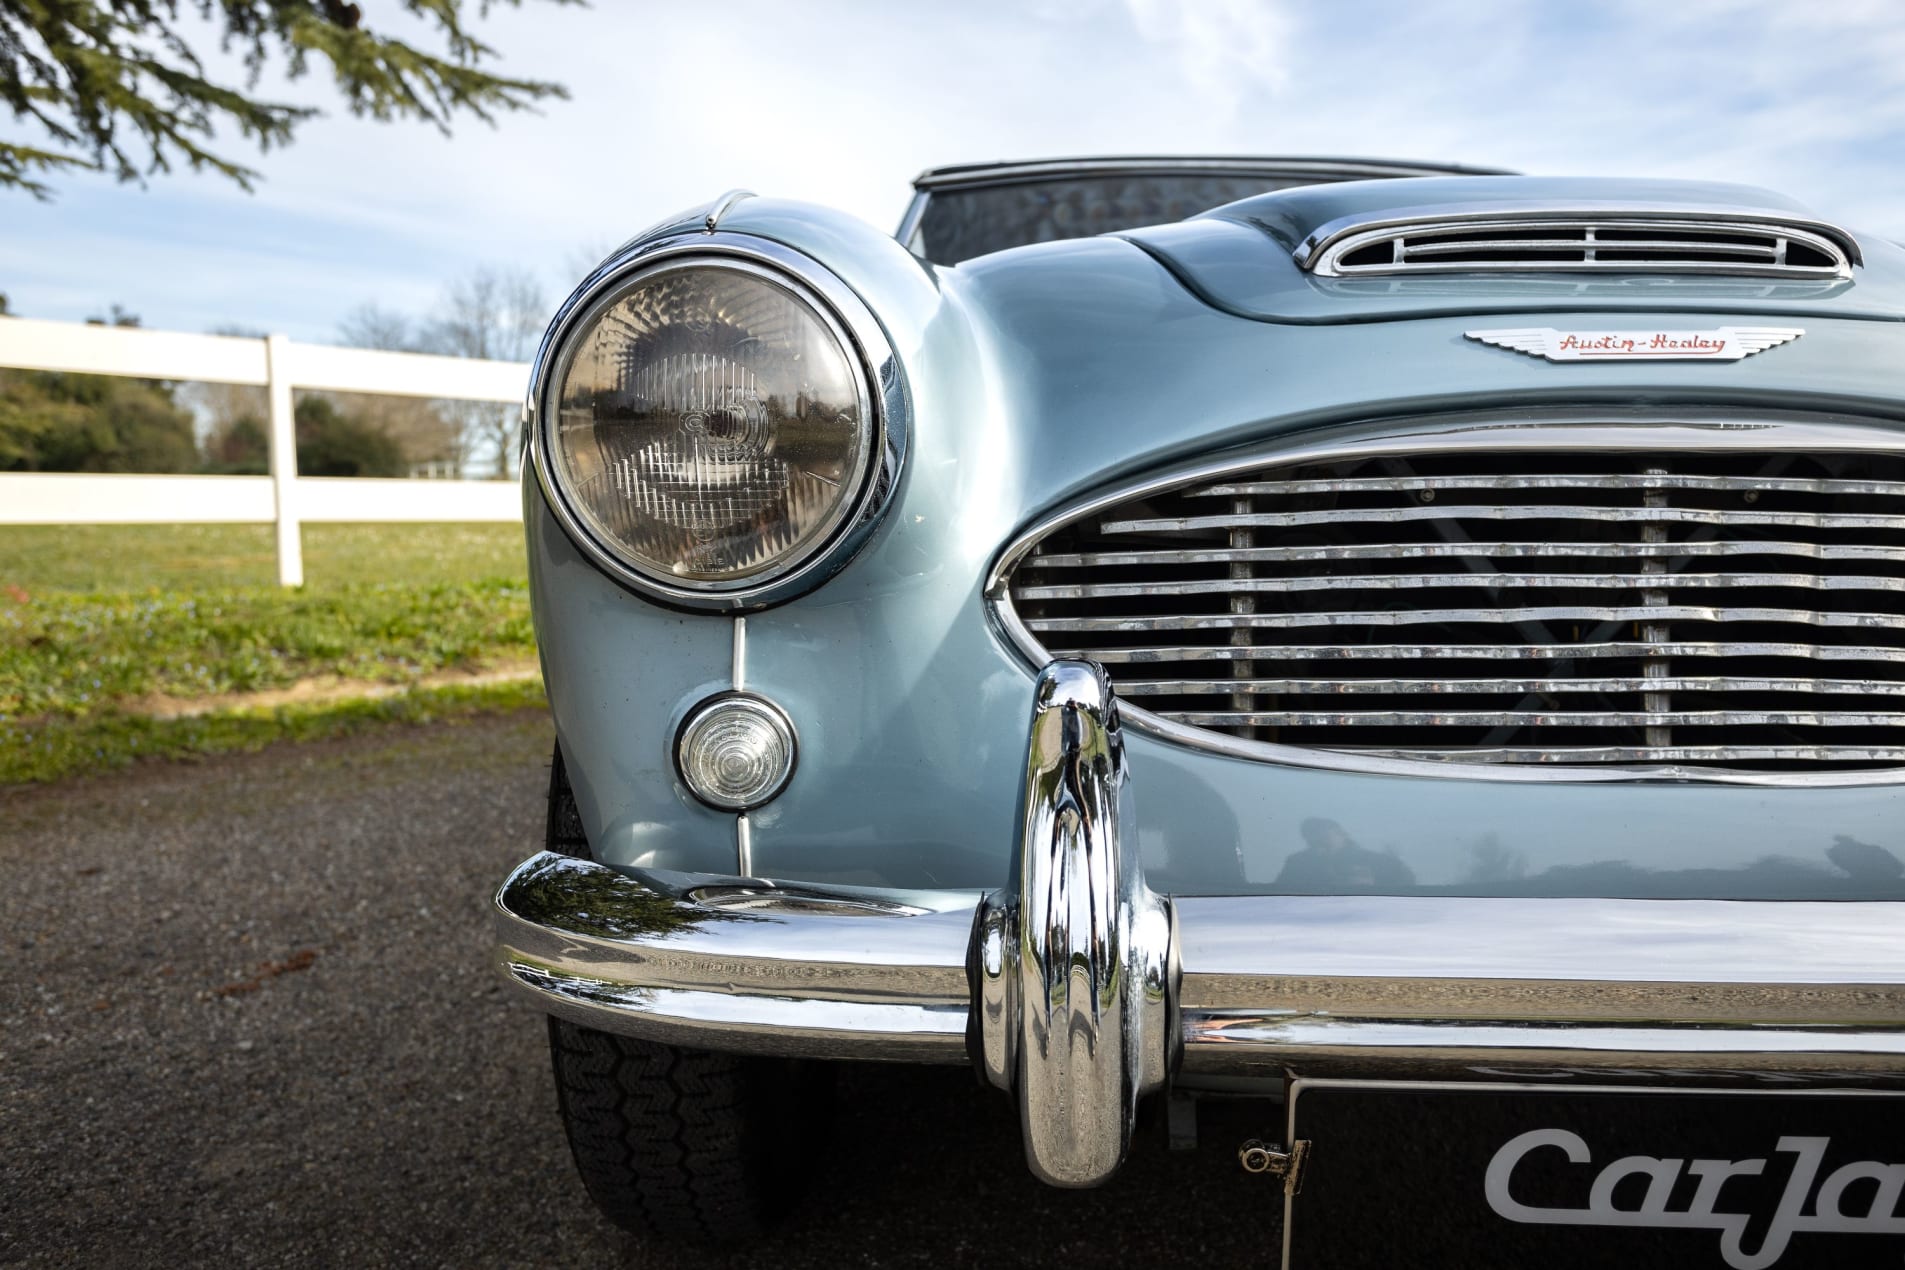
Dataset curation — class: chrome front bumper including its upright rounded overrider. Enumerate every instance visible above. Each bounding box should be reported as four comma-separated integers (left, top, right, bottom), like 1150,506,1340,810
495,661,1905,1186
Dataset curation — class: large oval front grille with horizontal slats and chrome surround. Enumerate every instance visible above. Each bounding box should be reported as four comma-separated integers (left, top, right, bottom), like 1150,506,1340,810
987,411,1905,784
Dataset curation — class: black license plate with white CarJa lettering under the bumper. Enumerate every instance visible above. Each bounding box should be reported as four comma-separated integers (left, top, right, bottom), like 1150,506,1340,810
1284,1081,1905,1270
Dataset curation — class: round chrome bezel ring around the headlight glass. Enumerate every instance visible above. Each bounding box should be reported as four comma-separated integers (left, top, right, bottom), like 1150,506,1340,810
524,232,911,613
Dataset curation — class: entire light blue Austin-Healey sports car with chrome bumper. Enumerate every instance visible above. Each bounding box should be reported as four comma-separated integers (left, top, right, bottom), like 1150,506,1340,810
495,158,1905,1270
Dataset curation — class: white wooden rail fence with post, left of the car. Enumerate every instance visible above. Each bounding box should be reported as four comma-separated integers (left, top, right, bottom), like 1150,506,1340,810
0,318,530,586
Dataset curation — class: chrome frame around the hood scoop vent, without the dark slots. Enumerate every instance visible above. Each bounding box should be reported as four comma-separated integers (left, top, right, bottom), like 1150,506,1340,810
1292,200,1865,278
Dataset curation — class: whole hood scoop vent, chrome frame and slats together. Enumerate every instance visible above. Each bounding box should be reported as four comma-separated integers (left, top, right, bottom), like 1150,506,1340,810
1295,204,1861,282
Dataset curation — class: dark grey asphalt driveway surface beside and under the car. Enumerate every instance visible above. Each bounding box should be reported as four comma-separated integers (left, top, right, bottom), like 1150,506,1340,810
0,714,1280,1268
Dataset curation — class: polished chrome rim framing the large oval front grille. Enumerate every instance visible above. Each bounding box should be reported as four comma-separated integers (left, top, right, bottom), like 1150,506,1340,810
985,411,1905,788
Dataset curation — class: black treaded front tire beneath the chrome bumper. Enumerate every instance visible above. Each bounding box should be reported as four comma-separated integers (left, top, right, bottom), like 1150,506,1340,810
549,746,831,1243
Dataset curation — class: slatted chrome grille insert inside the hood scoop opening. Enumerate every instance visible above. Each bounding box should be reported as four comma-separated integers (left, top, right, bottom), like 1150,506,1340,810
1301,217,1854,278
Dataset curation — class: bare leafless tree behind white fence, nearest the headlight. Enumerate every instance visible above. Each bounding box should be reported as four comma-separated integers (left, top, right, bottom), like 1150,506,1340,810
421,265,549,480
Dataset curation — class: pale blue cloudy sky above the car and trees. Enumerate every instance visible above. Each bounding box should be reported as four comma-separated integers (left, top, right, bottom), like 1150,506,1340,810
0,0,1905,341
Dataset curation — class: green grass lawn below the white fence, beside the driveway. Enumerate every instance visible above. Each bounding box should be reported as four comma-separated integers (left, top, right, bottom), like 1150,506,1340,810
0,526,541,783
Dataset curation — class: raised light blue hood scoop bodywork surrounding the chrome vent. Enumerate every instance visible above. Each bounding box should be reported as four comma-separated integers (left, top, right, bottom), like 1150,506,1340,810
1120,177,1905,324
